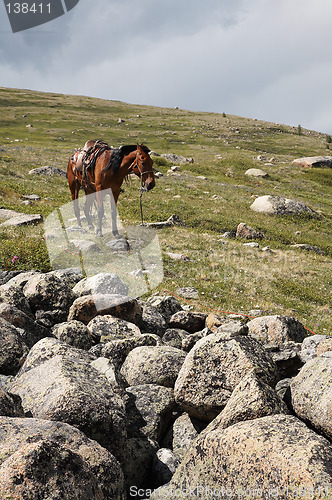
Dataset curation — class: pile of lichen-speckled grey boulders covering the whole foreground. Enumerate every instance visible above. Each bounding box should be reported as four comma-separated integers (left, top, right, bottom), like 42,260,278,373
0,269,332,500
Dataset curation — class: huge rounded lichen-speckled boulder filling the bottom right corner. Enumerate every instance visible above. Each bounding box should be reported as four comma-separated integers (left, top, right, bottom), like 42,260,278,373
151,415,332,500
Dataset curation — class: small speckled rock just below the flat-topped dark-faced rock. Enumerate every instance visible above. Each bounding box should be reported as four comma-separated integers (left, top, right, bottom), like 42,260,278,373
88,314,141,342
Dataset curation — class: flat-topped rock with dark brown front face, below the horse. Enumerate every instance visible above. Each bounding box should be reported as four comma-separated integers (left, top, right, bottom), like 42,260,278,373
68,294,142,325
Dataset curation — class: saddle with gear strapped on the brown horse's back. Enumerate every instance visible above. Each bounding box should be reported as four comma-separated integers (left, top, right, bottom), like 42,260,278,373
71,139,112,185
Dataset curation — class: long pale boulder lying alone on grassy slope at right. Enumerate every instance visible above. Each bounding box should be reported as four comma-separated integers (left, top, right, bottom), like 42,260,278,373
250,195,318,217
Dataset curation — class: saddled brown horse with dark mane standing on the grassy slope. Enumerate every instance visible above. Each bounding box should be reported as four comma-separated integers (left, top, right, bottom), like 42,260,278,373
67,140,155,238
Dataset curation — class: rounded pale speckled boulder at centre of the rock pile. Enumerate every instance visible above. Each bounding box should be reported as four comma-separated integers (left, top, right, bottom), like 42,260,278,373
121,346,186,387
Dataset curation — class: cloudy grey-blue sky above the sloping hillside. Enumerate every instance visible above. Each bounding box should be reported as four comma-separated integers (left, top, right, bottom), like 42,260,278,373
0,0,332,134
